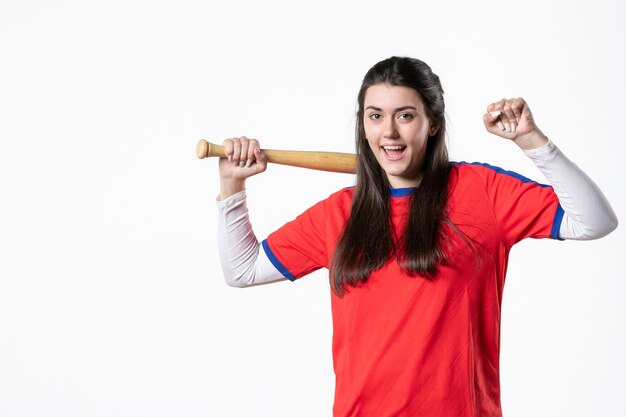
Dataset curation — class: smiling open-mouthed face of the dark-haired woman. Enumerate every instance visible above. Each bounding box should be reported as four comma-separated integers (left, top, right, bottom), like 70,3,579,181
363,84,436,188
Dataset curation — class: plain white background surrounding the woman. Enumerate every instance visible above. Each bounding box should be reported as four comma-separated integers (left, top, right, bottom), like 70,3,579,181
0,0,626,417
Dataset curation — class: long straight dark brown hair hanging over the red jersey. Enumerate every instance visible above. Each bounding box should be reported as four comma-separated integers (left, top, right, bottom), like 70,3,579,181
331,56,452,296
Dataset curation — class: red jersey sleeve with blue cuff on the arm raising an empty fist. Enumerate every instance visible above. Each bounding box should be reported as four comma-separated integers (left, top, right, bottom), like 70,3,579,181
460,163,563,247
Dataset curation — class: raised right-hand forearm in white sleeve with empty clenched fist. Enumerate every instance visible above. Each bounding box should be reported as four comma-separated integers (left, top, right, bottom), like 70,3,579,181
483,98,617,240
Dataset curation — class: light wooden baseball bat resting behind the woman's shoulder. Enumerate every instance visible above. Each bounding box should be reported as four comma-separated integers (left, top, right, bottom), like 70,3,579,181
196,139,356,174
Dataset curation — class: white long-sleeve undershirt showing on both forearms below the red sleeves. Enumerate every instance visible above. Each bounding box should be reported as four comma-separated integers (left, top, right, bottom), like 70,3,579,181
217,142,617,287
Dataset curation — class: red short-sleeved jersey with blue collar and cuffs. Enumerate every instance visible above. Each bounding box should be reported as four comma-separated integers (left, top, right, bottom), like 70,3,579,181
263,163,563,417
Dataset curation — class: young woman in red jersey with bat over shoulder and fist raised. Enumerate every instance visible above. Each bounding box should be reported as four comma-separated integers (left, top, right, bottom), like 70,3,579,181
218,57,617,417
